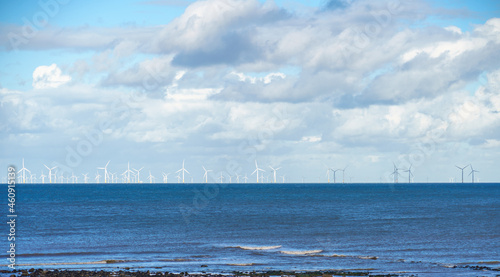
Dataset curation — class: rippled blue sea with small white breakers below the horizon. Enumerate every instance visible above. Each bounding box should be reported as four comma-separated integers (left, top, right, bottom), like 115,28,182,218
0,183,500,276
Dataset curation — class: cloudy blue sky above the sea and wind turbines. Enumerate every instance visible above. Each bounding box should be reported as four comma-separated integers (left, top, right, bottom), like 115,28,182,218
0,0,500,182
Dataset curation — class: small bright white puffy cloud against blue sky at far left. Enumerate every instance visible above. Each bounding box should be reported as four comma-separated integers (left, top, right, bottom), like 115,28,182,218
33,63,71,89
